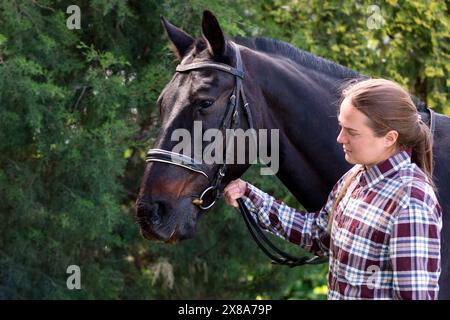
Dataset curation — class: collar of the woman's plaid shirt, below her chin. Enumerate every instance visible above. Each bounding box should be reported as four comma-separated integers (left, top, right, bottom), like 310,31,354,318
360,149,411,188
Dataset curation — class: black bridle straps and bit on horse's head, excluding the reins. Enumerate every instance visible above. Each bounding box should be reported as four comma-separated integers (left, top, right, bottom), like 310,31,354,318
146,42,253,210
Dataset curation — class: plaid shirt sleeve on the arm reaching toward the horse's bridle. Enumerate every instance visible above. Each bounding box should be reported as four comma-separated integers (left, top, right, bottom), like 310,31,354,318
242,180,341,256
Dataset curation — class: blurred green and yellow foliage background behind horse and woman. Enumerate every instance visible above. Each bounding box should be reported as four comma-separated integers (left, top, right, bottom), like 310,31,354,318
0,0,450,299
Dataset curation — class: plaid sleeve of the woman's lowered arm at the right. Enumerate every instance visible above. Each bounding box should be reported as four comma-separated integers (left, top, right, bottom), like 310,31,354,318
389,187,442,300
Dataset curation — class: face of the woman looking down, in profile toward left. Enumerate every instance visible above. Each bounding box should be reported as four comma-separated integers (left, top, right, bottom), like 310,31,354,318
337,98,398,167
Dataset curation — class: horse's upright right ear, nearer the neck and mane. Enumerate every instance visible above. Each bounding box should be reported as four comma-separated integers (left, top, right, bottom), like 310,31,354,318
202,10,226,57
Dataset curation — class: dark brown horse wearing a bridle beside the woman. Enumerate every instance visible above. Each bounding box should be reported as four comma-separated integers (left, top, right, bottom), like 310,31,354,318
136,11,450,299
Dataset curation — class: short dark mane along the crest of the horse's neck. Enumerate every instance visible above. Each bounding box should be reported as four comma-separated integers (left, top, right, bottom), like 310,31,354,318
232,37,427,112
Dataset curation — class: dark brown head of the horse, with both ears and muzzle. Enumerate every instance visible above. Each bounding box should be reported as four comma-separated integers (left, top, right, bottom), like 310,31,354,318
136,11,255,243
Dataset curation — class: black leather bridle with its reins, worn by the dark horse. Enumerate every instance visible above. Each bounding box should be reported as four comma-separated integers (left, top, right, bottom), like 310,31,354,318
146,41,325,267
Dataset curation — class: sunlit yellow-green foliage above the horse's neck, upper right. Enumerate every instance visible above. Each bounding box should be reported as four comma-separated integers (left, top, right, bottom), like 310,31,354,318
250,0,450,115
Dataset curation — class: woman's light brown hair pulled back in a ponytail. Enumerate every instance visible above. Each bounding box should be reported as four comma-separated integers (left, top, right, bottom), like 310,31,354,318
329,79,436,231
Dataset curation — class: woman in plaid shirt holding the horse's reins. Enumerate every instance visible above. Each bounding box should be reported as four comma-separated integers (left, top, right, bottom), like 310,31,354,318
224,79,442,299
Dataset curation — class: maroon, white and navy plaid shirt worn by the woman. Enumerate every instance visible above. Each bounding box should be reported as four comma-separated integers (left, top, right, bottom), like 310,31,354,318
243,151,442,299
